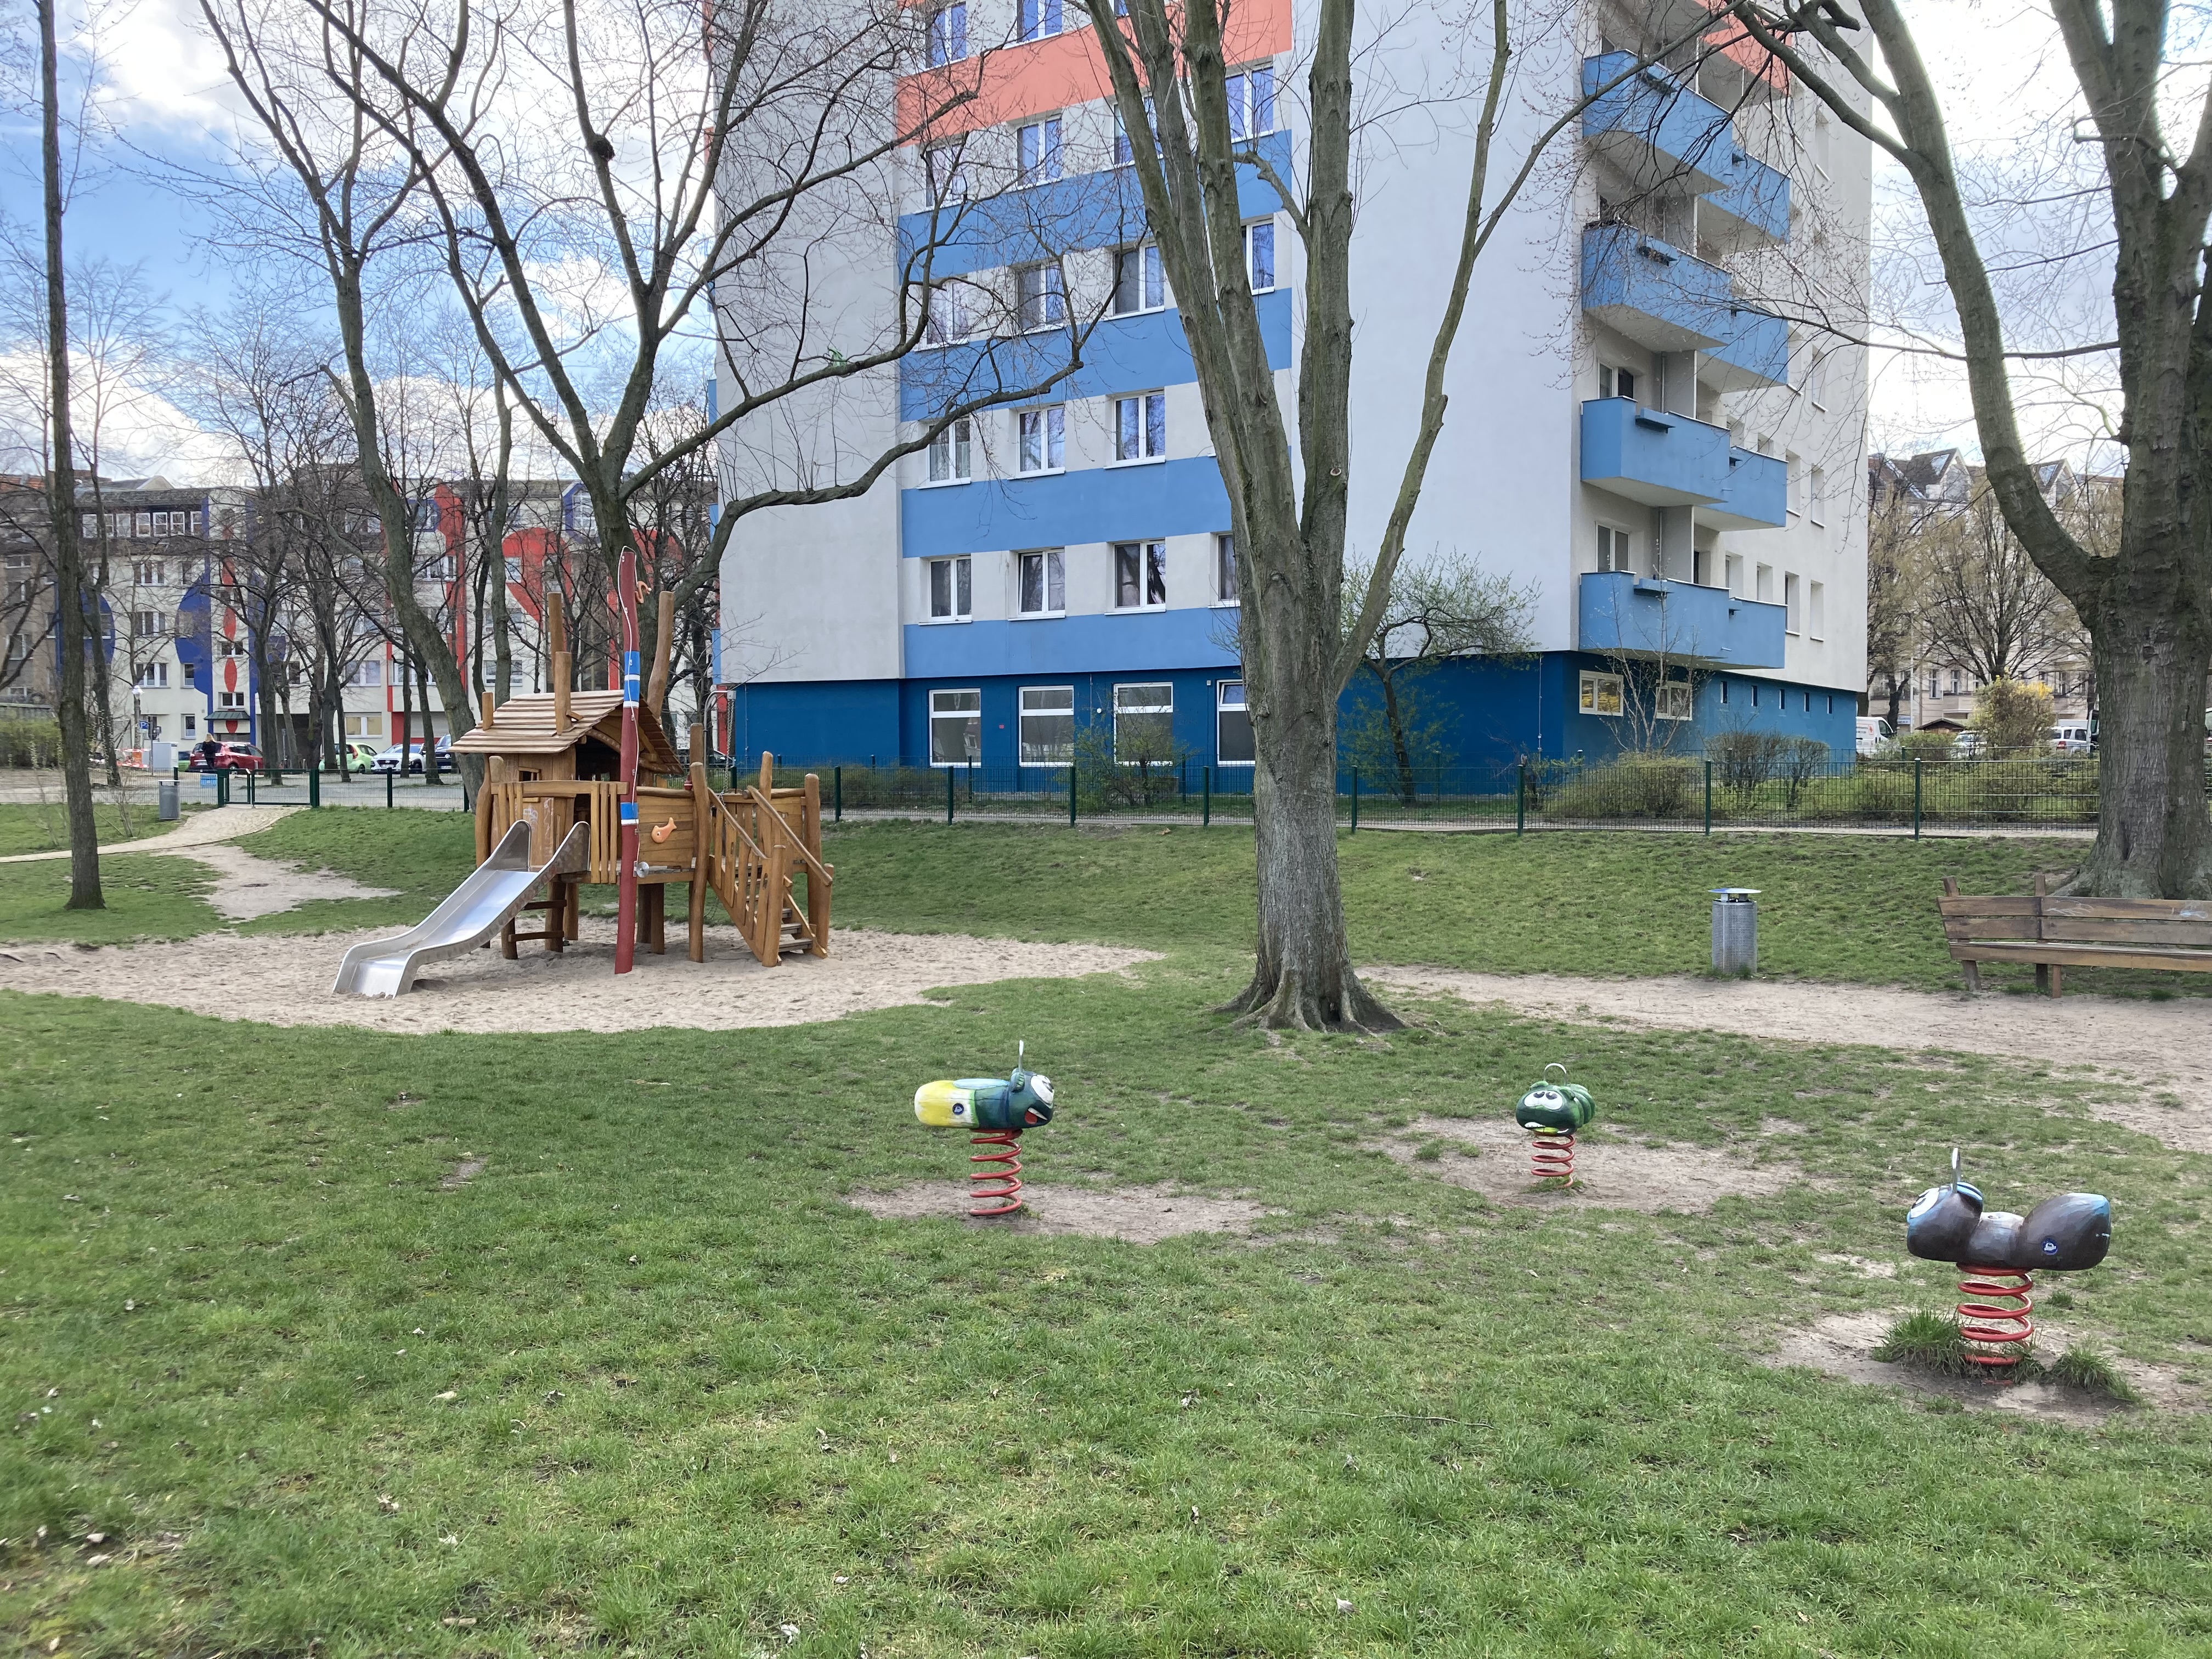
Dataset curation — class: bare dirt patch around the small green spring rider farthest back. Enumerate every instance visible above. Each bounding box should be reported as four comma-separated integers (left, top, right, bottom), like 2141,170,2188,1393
1383,1117,1801,1212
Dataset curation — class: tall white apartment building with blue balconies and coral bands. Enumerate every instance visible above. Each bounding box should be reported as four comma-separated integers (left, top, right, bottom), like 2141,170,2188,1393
723,0,1871,776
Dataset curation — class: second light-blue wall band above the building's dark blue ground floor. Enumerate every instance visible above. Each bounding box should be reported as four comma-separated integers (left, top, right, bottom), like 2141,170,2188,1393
898,456,1230,560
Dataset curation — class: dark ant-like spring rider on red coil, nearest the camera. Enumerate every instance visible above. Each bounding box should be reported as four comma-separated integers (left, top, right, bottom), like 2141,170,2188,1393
1905,1146,2113,1380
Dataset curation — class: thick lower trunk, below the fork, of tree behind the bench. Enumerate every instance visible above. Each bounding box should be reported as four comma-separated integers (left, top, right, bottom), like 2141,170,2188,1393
2070,604,2212,898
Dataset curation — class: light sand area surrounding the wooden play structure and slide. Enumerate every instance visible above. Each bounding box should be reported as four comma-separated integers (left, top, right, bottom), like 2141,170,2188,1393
0,918,1155,1033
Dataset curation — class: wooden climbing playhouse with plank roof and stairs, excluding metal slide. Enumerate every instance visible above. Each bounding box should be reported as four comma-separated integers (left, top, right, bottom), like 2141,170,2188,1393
454,593,832,971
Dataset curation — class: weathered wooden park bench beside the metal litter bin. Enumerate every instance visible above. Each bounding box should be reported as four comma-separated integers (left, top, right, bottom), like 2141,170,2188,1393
1942,876,2212,995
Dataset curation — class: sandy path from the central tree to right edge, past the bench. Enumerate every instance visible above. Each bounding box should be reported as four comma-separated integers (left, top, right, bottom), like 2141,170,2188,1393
1361,967,2212,1153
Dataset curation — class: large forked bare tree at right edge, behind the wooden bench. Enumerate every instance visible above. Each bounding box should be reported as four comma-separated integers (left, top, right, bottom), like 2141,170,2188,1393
1730,0,2212,896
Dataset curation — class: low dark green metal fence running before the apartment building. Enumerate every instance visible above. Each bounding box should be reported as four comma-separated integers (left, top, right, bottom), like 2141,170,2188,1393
163,757,2185,834
